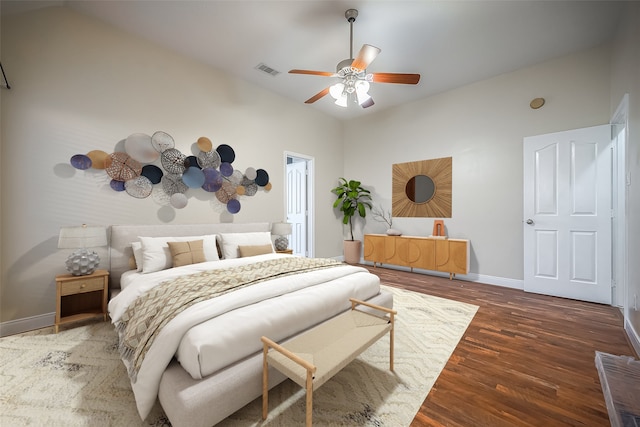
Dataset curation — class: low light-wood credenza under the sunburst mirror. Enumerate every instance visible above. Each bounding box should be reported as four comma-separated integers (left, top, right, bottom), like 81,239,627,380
364,234,469,279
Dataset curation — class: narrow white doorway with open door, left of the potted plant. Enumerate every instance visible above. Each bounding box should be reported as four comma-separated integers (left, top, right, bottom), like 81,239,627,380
284,152,314,257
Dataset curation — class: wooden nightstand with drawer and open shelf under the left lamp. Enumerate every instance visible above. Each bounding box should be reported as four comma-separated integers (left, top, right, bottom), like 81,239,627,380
55,270,109,334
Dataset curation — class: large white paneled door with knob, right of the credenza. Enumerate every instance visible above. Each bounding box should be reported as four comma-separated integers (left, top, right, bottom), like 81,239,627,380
523,125,611,304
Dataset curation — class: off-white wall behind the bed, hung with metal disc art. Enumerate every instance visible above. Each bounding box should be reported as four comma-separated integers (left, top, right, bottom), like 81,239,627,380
0,7,343,322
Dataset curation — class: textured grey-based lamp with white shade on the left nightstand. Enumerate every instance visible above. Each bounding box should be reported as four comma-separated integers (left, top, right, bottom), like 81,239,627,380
58,224,107,276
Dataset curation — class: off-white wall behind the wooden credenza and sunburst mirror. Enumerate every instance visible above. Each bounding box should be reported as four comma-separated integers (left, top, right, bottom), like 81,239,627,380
344,46,610,282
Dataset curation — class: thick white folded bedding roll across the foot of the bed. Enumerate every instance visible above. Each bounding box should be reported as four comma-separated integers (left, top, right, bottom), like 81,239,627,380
177,272,380,379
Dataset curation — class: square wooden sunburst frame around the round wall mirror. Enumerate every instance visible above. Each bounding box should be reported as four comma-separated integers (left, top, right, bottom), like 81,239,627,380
391,157,453,218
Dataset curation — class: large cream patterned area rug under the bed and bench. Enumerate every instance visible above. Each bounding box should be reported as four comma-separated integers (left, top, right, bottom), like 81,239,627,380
0,286,478,427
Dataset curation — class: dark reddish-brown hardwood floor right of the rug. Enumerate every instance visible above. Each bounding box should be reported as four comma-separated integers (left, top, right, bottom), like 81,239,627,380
365,266,637,427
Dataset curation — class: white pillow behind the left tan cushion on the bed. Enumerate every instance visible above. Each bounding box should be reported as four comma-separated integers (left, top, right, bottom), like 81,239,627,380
138,234,220,273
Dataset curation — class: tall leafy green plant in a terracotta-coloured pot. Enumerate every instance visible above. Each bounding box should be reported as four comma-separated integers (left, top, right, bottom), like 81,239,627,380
331,178,371,264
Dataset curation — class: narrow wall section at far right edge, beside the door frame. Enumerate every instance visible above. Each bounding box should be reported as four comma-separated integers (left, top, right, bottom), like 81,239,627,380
611,2,640,353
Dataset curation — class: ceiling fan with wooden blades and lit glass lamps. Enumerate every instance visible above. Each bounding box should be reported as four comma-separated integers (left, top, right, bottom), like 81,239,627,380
289,9,420,108
